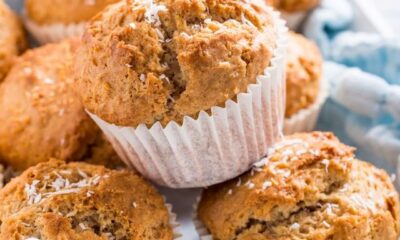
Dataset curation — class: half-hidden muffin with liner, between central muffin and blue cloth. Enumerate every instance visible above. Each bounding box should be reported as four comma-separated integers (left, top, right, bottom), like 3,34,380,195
284,32,328,134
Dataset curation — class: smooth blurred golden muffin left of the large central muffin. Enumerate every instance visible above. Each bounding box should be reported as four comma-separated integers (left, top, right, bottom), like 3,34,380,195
0,40,123,170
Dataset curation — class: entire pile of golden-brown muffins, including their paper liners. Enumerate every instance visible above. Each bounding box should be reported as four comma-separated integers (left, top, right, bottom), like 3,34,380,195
0,0,400,240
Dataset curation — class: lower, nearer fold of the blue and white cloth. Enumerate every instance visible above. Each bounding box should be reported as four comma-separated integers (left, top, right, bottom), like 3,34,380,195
317,62,400,172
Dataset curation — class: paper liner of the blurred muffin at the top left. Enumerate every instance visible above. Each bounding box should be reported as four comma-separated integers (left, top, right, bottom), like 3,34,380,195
24,17,86,44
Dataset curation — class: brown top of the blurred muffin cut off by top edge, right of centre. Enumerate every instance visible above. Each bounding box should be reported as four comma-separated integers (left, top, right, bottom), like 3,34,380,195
266,0,320,13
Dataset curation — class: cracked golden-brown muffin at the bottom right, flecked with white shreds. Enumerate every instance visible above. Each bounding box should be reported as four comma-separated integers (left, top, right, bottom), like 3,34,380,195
198,132,400,240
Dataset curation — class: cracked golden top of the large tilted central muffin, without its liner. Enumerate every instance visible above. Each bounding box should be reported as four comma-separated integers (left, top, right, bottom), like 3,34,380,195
75,0,276,127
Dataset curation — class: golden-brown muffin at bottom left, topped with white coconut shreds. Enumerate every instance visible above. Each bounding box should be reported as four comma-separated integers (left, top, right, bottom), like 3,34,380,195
0,160,173,240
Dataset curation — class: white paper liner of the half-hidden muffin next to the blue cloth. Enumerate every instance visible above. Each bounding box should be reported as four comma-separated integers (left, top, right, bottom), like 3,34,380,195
284,79,329,135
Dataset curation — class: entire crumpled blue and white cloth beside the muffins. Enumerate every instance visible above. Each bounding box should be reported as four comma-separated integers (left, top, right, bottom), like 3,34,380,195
303,0,400,176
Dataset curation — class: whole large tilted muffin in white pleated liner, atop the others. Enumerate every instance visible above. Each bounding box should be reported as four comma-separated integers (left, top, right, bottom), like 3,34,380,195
75,0,285,187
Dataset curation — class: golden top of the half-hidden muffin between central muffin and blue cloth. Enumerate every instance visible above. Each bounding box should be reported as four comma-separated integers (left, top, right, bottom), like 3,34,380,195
285,32,323,118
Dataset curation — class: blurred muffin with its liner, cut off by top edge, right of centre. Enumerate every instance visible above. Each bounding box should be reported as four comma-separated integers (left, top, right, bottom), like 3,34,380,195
266,0,320,29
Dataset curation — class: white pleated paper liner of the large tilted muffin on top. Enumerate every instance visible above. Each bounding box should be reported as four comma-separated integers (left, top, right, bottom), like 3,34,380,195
88,9,287,188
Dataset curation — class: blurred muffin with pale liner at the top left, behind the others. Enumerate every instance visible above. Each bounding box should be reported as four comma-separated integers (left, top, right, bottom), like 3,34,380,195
25,0,118,43
